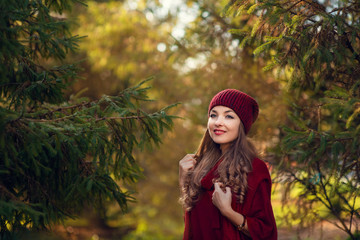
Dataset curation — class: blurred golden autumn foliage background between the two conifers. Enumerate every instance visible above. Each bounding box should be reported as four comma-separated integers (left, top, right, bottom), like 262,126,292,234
9,0,358,240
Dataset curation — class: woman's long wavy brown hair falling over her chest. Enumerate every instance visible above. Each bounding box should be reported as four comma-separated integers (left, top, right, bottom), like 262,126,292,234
180,123,256,211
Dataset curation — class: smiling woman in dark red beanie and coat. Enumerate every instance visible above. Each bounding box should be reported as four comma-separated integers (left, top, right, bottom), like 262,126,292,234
179,89,277,240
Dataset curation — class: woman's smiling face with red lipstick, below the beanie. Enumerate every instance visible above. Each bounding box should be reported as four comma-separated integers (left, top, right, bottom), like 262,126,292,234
207,106,241,151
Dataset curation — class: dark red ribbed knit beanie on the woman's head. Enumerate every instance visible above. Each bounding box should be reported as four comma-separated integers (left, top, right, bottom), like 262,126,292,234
208,89,259,134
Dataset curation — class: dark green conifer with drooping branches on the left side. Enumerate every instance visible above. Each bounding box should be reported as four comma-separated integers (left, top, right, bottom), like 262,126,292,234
0,0,174,239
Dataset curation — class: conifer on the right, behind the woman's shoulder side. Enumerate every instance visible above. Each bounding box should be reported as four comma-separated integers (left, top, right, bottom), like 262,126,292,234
224,0,360,239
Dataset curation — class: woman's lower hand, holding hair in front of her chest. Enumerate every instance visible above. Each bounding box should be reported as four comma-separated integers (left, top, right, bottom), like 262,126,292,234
212,182,232,216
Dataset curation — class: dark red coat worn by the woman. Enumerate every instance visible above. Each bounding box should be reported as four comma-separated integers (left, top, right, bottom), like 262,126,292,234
183,158,277,240
